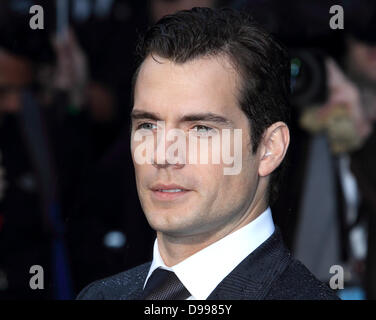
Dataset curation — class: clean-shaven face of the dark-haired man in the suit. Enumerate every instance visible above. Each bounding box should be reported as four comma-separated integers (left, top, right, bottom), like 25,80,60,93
131,56,259,236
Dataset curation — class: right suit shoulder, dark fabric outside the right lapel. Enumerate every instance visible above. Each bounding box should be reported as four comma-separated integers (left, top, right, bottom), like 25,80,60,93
266,259,339,300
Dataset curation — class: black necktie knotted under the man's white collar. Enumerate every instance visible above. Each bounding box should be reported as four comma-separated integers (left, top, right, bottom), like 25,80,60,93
142,268,191,300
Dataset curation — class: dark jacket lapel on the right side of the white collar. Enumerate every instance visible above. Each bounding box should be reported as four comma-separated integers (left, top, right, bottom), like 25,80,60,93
208,226,292,300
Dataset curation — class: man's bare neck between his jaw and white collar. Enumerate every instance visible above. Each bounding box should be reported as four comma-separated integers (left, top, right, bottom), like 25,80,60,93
157,201,267,267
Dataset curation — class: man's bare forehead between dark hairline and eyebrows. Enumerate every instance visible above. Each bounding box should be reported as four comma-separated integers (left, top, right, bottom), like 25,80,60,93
134,56,241,117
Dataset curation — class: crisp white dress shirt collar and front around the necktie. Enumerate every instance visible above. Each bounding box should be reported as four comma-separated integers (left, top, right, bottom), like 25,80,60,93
144,208,275,300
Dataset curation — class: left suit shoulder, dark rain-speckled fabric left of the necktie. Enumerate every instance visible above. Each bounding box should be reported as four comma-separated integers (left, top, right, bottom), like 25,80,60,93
76,263,150,300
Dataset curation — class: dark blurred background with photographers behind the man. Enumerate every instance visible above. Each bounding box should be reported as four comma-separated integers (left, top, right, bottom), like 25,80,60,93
0,0,376,300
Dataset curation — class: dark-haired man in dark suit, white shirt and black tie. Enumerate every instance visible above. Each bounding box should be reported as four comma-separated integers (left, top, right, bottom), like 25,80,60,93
78,8,337,299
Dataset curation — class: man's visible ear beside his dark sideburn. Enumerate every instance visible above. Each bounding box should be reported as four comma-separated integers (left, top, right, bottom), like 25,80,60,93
258,121,290,177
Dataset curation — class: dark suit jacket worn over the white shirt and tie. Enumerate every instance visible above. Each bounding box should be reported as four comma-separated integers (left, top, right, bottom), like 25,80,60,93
77,227,339,300
